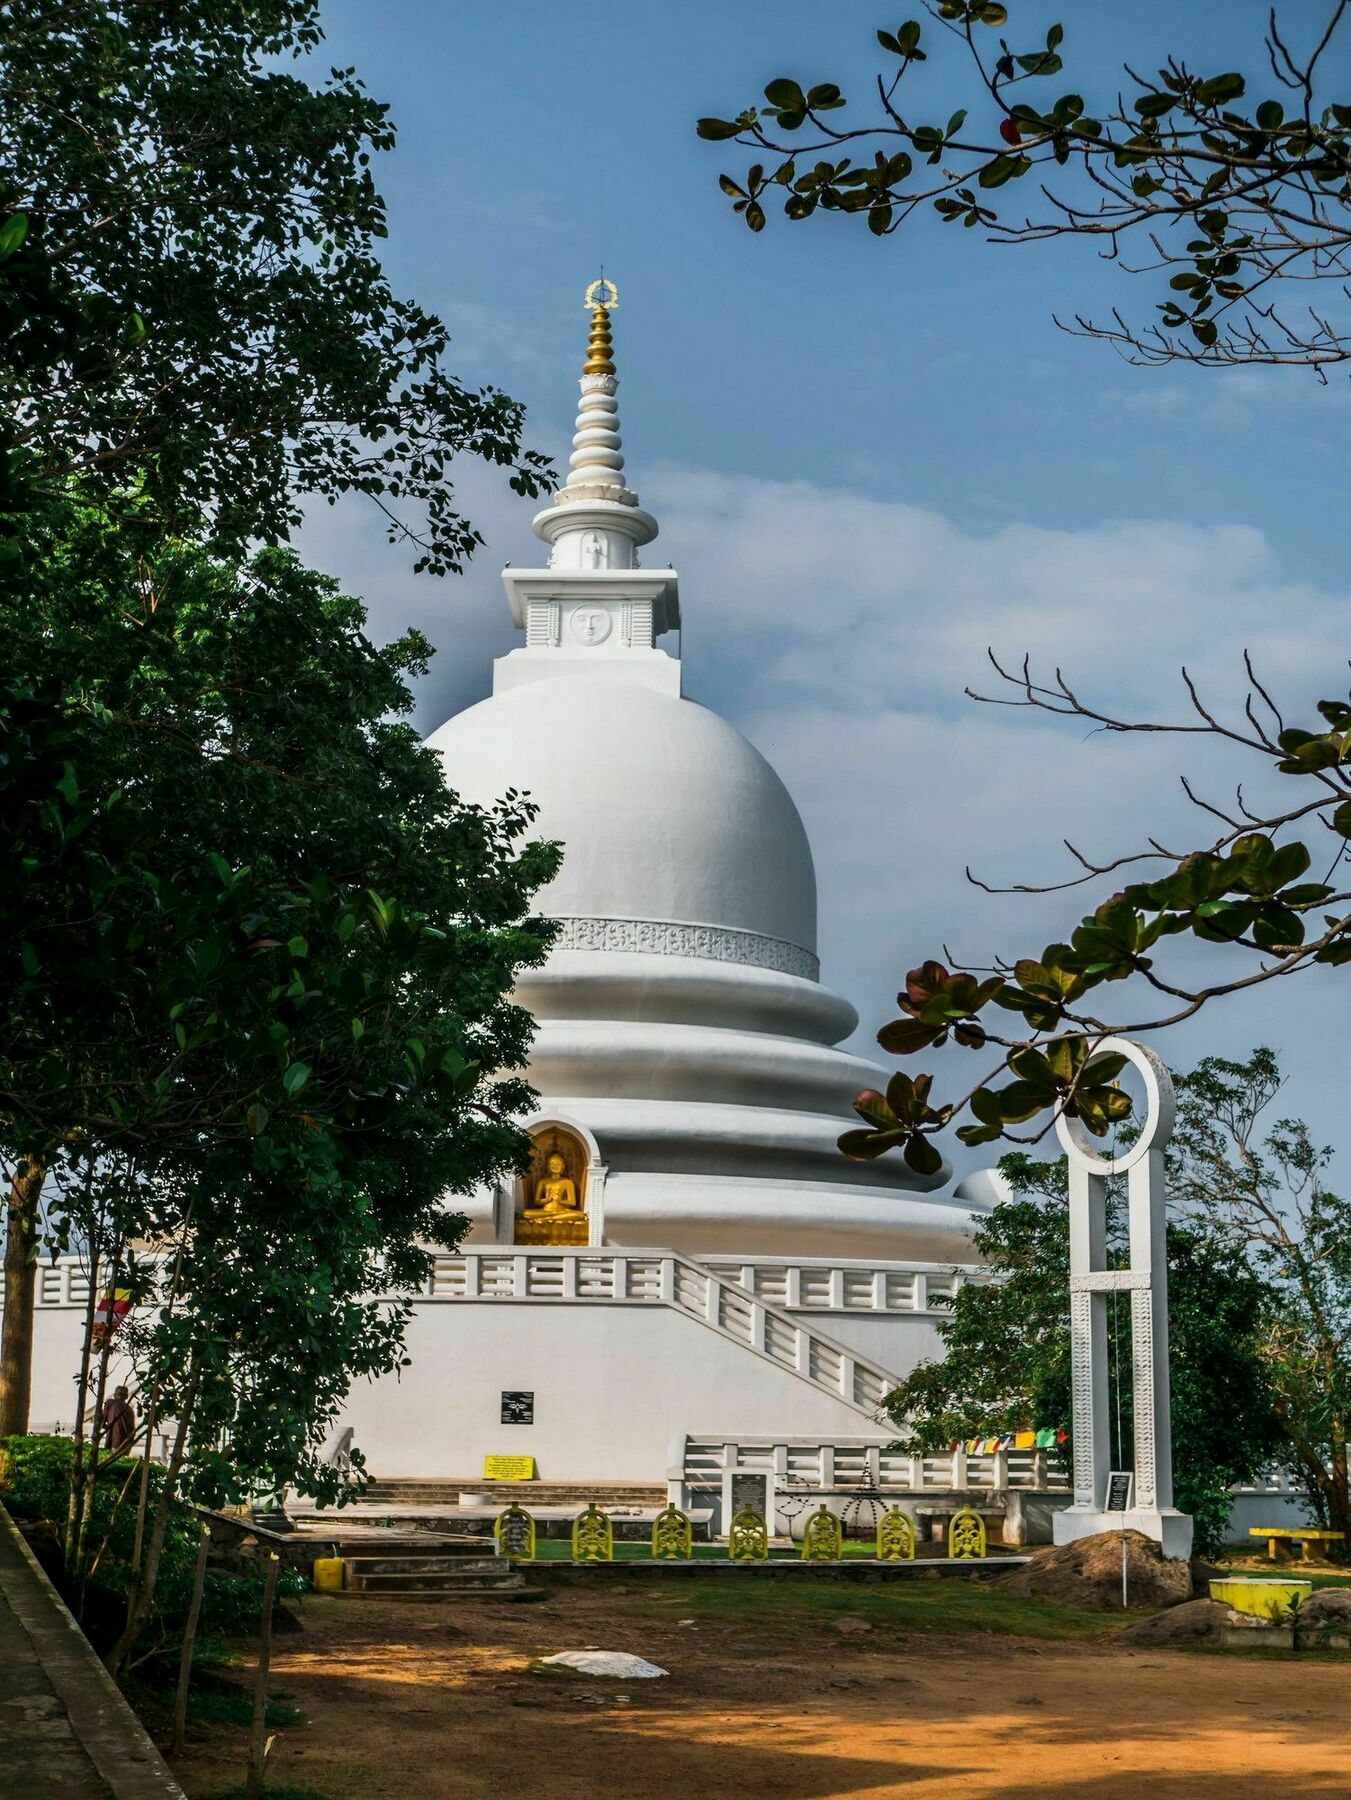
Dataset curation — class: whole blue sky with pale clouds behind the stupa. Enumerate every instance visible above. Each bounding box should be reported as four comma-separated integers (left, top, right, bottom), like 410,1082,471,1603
302,0,1351,1181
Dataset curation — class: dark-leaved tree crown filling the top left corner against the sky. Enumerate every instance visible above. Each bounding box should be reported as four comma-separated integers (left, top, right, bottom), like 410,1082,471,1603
0,0,549,572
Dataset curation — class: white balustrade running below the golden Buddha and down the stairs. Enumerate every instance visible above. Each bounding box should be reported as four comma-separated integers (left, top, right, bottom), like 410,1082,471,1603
425,1246,899,1426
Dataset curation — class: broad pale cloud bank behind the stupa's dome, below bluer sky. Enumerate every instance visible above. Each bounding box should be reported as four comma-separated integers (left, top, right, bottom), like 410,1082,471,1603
304,453,1351,1166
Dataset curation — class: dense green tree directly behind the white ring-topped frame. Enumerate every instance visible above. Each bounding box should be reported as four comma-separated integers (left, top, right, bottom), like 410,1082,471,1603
887,1053,1290,1552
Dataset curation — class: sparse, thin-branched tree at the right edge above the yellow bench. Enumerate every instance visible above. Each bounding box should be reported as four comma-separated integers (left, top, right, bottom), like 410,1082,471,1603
1171,1049,1351,1544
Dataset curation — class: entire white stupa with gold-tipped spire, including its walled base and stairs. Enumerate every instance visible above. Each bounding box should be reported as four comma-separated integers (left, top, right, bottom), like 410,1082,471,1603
23,283,984,1525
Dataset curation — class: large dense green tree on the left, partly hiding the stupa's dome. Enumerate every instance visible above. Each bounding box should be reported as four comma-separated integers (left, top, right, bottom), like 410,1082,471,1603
0,500,558,1663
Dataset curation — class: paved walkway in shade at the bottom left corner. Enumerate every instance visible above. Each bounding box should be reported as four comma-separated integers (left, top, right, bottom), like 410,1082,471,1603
0,1507,183,1800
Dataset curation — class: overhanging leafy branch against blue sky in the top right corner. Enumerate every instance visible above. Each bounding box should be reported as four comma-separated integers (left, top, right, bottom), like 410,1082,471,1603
698,0,1351,371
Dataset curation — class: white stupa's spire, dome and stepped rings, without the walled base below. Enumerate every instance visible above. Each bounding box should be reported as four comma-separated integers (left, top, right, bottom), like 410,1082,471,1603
430,288,970,1258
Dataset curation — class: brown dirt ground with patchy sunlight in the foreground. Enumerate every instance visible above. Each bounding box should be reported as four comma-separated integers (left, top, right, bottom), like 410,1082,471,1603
176,1582,1351,1800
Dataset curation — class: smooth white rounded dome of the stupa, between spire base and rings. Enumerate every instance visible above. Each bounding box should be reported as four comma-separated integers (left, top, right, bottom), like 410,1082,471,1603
428,673,817,972
